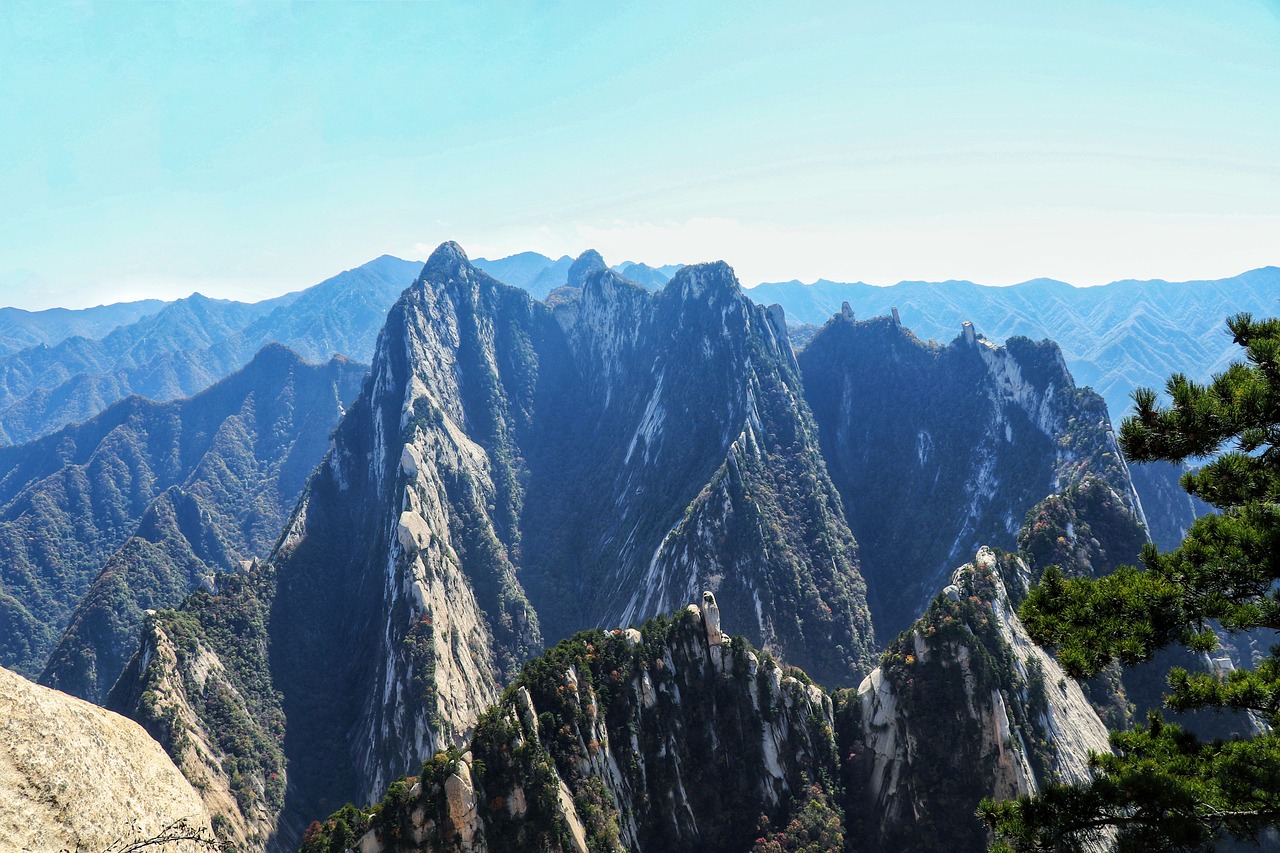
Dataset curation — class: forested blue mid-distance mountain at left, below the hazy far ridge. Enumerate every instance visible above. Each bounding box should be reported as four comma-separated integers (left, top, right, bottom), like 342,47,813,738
0,346,364,681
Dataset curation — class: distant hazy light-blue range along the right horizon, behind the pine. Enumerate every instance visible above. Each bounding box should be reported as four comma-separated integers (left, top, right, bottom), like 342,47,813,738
748,266,1280,421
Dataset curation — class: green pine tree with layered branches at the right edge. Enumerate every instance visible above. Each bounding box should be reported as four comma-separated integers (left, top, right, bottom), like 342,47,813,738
978,314,1280,852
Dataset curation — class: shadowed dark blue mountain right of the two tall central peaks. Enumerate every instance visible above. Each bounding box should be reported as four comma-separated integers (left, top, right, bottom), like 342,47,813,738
799,313,1140,634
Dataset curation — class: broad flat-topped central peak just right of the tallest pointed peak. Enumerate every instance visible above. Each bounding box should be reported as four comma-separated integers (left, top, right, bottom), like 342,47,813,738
521,264,872,684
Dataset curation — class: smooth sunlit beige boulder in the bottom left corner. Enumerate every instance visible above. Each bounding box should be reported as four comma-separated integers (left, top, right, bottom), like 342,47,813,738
0,669,211,850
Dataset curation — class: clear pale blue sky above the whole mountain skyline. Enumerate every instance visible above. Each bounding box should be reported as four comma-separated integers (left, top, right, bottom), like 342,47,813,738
0,0,1280,307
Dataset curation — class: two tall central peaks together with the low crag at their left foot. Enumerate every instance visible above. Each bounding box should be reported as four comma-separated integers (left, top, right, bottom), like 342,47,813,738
113,243,873,847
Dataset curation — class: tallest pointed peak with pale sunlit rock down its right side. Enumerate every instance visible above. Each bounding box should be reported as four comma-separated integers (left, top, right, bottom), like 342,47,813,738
270,245,550,833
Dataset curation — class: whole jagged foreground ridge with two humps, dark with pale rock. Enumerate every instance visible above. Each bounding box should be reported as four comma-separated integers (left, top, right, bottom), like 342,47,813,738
296,558,1108,853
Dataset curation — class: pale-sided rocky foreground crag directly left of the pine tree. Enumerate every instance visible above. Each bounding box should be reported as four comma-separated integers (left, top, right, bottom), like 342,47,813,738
849,548,1110,850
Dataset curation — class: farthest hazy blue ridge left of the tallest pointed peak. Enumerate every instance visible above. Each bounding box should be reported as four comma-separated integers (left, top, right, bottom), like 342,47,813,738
0,255,421,444
